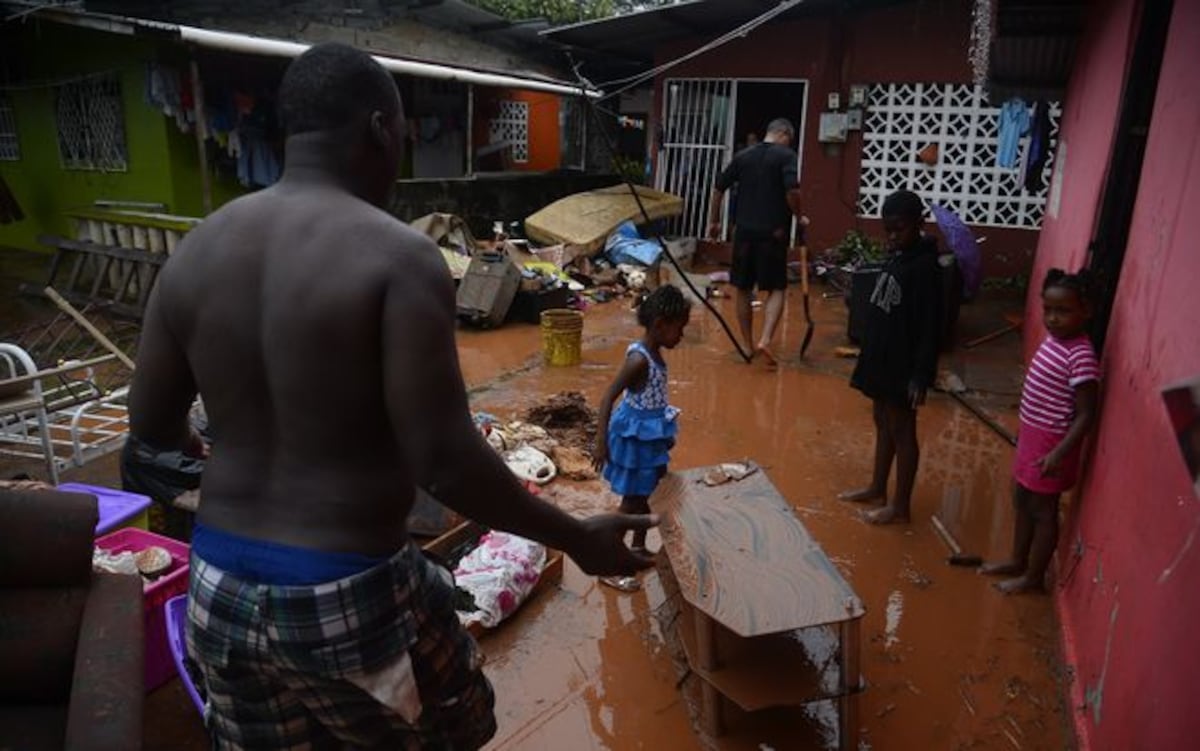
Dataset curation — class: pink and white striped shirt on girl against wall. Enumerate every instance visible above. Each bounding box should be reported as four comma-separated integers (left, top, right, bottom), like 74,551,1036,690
1021,336,1100,433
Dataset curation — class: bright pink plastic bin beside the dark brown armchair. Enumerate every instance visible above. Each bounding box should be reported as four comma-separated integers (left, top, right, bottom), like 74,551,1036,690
96,527,191,693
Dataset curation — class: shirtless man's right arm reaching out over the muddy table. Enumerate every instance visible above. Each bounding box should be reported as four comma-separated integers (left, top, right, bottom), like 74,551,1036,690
380,238,655,576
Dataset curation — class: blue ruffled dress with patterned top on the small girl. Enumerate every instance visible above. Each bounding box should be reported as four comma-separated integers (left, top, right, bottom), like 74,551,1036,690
604,342,679,495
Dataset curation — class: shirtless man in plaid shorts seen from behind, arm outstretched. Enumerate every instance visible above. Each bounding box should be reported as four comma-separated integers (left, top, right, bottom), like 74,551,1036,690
130,44,656,750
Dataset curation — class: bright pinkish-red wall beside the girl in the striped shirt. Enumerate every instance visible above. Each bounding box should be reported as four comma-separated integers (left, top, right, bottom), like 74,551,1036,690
1026,0,1200,751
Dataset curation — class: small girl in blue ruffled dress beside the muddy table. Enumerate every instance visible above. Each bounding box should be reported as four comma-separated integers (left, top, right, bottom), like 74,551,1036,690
594,284,691,589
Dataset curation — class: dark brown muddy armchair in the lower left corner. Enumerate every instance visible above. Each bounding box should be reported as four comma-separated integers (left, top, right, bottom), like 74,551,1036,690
0,488,144,751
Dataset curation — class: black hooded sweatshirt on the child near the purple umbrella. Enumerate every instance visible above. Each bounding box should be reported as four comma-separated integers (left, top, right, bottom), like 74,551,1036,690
850,235,943,404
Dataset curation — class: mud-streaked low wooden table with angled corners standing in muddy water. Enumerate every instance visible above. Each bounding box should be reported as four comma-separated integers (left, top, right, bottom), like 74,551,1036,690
650,468,865,750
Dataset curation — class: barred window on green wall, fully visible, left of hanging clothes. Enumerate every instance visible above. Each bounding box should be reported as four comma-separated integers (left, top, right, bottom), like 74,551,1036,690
54,74,128,172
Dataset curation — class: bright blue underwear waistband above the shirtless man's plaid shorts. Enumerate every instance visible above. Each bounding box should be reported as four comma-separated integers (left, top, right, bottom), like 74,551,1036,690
192,522,388,587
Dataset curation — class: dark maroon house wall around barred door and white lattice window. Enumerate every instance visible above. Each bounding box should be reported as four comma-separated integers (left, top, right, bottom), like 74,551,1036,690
652,0,1038,276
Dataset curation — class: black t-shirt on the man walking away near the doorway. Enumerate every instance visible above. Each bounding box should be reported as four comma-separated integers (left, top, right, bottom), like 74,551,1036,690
716,142,798,235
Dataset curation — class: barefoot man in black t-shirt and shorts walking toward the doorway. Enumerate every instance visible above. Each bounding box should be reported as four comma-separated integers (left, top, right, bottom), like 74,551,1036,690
708,119,800,366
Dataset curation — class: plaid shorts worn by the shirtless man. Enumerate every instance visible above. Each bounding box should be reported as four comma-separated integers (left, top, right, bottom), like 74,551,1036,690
187,543,496,751
